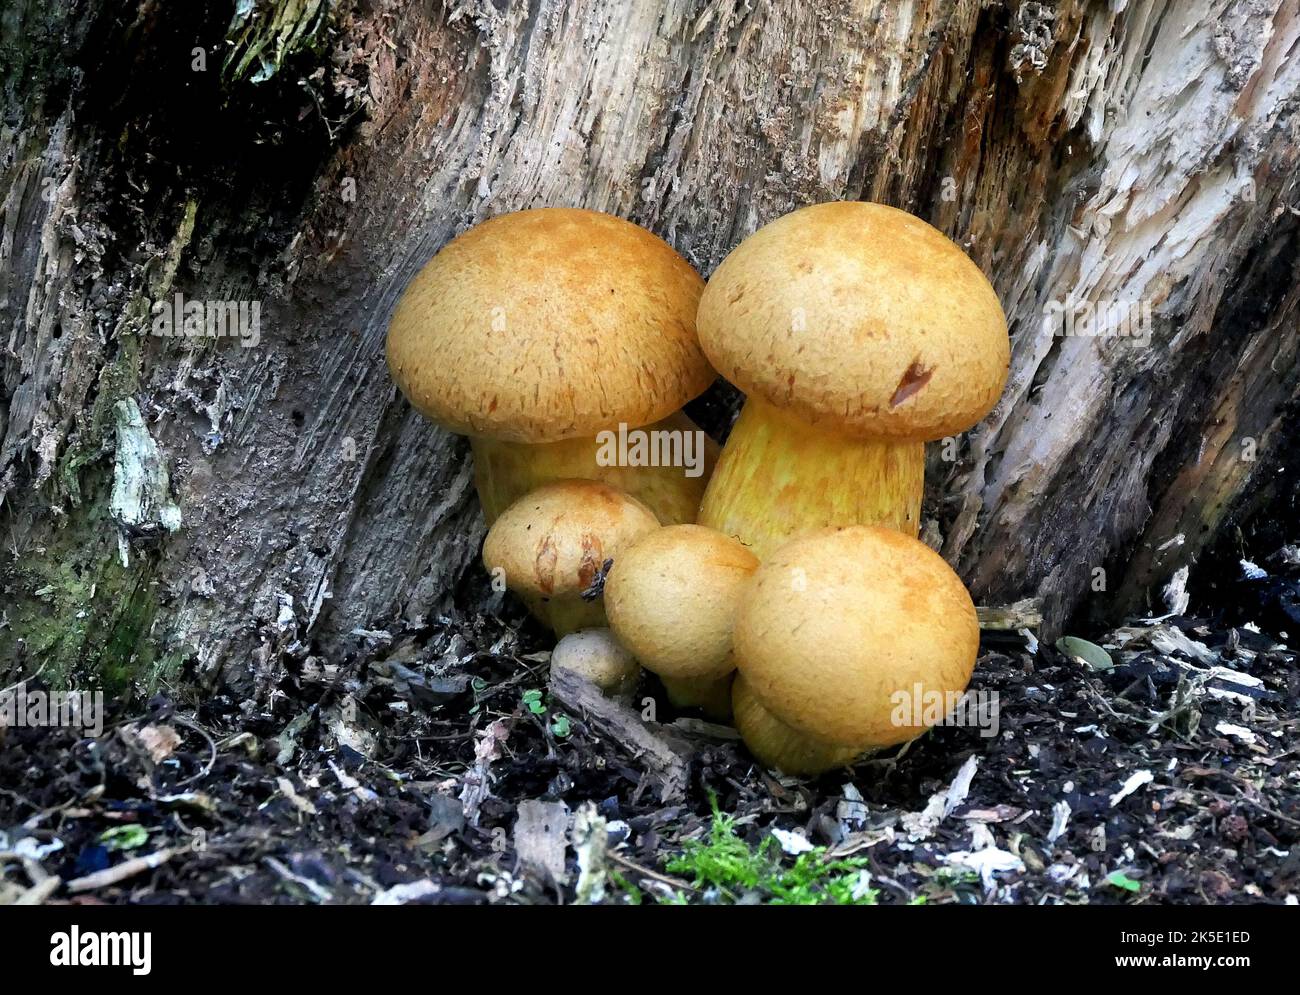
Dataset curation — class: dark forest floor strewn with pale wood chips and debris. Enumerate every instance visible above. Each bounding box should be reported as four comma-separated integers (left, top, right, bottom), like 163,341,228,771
0,577,1300,904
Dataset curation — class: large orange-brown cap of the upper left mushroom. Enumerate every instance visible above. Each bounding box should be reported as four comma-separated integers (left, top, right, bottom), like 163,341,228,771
387,208,715,442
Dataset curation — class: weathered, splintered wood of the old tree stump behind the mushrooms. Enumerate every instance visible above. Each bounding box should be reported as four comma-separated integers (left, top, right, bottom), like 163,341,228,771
0,0,1300,697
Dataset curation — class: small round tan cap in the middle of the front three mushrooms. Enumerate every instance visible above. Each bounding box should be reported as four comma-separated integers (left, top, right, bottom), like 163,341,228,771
605,525,758,680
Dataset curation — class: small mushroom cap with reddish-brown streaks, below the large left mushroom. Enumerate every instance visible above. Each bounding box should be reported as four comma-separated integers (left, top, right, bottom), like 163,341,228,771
484,480,659,598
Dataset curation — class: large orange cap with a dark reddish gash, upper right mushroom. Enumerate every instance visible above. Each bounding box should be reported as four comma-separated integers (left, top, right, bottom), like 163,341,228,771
698,202,1010,441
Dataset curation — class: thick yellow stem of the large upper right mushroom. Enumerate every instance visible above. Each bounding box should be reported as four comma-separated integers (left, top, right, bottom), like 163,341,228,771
699,397,926,559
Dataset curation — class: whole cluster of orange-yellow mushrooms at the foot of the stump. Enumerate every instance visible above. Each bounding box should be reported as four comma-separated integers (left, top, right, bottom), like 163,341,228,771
387,202,1009,774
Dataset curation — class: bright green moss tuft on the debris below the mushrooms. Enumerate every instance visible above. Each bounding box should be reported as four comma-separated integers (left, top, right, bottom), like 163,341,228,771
664,804,879,905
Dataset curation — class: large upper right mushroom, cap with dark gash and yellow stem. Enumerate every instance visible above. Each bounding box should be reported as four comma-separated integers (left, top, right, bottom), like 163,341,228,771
698,202,1010,559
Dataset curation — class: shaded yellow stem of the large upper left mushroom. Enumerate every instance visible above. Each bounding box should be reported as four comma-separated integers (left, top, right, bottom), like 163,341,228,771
471,411,718,522
